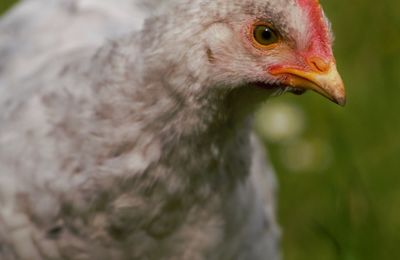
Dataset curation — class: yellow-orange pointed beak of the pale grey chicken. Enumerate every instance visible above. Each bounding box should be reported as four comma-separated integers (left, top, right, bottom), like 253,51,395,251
270,62,346,106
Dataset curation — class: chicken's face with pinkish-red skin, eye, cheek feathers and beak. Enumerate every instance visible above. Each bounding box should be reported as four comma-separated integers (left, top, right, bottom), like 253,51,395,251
202,0,346,105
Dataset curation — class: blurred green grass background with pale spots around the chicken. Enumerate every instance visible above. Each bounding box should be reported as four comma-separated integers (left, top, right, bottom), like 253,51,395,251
0,0,400,260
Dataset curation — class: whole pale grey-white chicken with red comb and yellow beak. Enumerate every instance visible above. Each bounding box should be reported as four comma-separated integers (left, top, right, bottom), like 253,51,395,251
0,0,345,260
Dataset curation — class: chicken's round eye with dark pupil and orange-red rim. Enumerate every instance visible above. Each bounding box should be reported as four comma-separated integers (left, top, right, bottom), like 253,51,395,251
251,23,280,48
